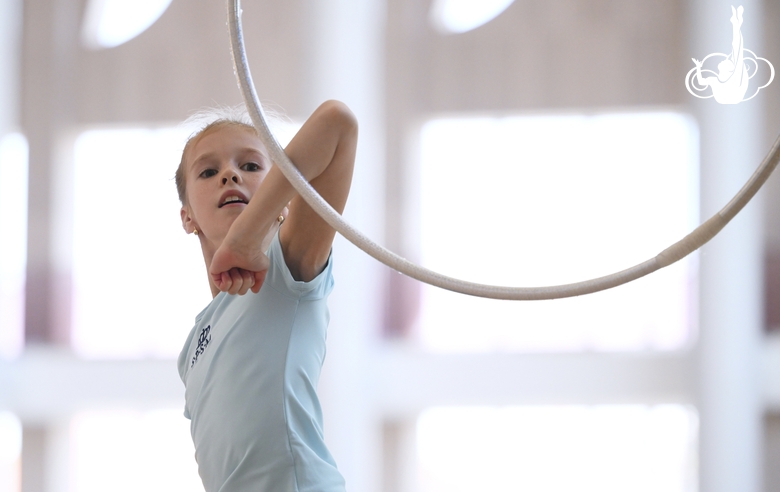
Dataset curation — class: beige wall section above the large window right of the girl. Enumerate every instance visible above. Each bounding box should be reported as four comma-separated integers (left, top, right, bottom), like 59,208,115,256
389,0,687,111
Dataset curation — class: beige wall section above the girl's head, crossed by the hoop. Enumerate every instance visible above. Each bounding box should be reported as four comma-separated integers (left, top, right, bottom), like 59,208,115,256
70,0,307,123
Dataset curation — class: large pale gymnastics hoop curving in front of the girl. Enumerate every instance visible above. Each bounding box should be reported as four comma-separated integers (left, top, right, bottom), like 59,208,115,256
227,0,780,301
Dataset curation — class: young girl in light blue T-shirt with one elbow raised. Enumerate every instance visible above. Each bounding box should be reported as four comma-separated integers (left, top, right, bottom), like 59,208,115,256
176,101,357,492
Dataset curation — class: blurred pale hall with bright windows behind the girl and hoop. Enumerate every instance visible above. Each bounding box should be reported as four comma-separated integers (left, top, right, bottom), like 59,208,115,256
0,0,780,492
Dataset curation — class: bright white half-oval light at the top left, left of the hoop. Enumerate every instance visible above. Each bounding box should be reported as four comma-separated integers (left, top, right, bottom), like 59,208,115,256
81,0,171,49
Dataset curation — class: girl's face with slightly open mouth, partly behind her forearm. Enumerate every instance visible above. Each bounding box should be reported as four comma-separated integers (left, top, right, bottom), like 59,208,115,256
181,125,271,251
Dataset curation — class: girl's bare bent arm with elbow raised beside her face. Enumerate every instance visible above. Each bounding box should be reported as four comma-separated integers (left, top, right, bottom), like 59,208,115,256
209,101,357,292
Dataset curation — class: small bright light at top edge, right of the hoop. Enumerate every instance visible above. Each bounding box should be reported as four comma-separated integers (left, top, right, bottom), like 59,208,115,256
430,0,514,34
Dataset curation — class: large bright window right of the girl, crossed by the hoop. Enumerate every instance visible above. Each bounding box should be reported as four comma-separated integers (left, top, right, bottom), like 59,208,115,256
417,112,698,352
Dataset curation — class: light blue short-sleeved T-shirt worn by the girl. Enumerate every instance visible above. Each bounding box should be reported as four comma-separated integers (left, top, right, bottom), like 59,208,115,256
178,235,344,492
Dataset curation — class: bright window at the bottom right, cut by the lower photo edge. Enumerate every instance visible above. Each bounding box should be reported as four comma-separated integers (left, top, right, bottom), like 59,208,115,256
417,405,697,492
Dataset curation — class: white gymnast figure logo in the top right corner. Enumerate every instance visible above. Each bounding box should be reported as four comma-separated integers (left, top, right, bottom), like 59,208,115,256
685,5,775,104
